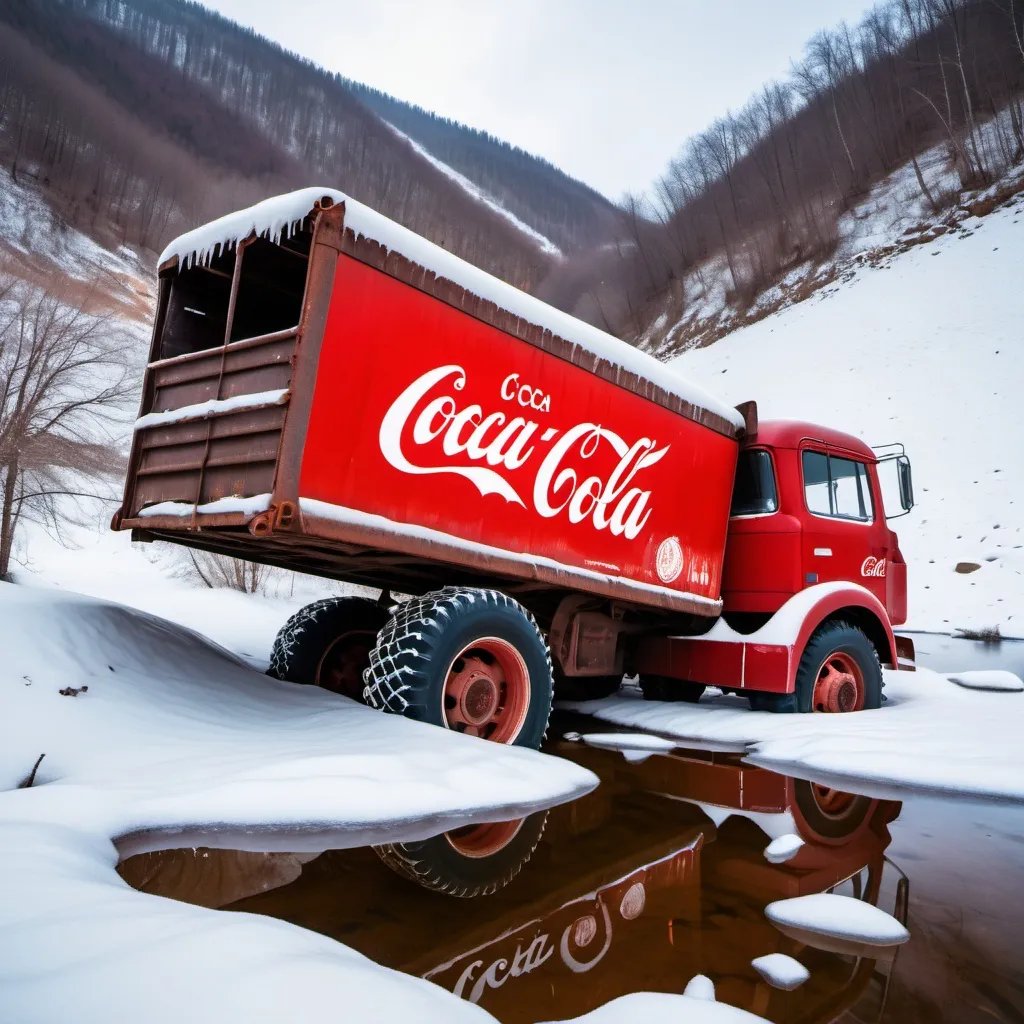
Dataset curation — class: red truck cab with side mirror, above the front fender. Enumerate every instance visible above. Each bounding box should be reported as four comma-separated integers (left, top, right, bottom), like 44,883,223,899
722,421,912,632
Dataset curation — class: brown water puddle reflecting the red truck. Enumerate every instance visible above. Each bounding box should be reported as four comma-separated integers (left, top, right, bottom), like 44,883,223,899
120,720,1024,1024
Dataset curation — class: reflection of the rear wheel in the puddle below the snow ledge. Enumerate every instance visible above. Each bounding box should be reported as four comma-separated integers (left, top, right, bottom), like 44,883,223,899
374,811,548,898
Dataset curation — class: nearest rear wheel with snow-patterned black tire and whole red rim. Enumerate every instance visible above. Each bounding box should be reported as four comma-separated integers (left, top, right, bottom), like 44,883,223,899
364,587,552,749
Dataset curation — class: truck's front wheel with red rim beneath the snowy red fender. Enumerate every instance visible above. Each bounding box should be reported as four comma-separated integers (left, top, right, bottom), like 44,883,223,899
749,620,882,714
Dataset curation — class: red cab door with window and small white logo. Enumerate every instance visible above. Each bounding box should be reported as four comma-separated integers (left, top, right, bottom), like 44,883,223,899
800,445,889,604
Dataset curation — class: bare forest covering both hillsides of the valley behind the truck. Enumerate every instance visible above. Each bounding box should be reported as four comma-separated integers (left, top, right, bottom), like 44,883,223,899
0,0,1024,340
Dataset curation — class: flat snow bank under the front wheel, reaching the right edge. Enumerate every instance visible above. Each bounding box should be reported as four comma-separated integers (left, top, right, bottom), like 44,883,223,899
564,669,1024,802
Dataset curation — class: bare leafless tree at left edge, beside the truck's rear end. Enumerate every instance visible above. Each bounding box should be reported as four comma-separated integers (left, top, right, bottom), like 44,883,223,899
0,276,136,579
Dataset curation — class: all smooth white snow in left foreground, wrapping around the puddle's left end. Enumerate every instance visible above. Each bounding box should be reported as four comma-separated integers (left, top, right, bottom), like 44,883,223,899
0,584,597,1024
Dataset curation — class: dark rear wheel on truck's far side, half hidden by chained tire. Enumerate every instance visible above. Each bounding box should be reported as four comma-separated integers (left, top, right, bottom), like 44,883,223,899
266,597,387,702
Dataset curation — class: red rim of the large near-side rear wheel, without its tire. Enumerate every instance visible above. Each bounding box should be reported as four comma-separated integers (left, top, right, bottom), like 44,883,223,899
441,637,529,743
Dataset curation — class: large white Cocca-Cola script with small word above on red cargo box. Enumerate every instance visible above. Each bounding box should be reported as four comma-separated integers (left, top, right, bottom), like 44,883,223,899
379,364,671,541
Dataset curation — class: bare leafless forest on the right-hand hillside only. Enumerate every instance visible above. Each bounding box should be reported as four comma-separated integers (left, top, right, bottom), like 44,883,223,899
561,0,1024,339
